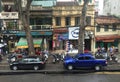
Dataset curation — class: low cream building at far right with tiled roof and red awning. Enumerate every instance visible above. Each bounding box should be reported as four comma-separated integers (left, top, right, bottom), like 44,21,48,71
95,16,120,51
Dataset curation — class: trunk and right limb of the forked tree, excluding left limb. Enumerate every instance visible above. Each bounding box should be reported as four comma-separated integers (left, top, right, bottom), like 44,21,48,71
23,0,35,55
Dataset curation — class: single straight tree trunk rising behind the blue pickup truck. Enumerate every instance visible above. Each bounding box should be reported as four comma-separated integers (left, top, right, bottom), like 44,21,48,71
78,0,89,53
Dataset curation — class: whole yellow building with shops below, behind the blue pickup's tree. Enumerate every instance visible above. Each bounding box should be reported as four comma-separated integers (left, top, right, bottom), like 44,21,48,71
53,0,94,51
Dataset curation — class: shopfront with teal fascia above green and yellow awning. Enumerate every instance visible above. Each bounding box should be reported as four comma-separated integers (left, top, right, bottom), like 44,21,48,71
16,31,52,50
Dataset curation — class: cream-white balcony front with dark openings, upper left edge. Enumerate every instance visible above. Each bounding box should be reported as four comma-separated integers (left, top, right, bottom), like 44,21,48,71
0,12,19,19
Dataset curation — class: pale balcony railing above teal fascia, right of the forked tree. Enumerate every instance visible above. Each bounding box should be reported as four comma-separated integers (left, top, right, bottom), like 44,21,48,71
30,25,52,31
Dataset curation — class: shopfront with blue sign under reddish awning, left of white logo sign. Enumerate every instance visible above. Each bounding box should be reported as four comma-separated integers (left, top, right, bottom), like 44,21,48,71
52,27,68,50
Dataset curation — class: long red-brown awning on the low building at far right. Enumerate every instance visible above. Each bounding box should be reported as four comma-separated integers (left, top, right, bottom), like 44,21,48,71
95,35,120,42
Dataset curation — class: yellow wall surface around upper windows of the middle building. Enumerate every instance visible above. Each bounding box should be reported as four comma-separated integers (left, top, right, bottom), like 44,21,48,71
53,3,95,51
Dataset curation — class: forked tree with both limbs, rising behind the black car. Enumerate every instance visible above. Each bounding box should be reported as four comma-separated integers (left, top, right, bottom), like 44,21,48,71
15,0,35,55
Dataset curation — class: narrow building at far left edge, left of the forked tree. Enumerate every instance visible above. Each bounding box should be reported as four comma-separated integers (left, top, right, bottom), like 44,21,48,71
0,0,19,54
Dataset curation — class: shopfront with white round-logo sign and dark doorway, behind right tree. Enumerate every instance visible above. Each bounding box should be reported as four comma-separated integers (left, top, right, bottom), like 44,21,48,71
69,27,92,50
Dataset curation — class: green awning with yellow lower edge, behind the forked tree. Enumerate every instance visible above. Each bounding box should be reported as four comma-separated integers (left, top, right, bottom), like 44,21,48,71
16,38,42,48
